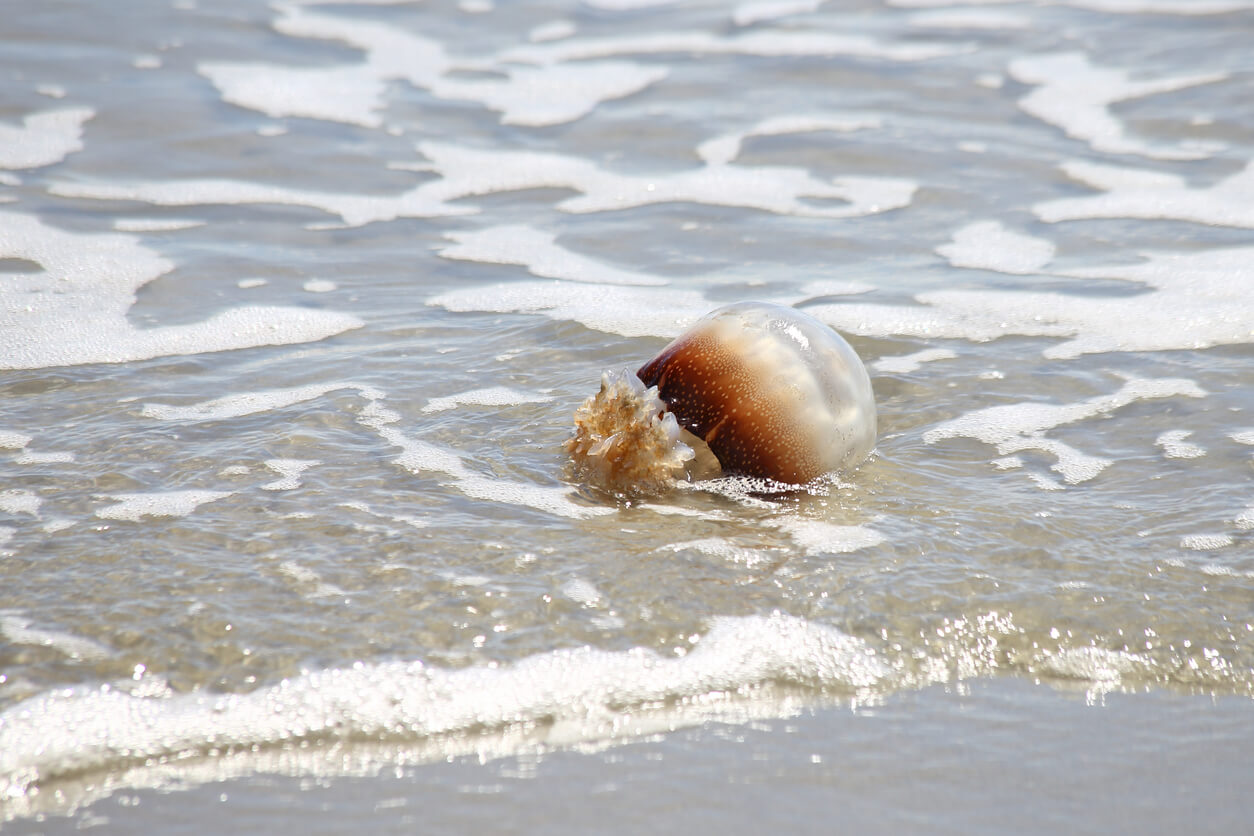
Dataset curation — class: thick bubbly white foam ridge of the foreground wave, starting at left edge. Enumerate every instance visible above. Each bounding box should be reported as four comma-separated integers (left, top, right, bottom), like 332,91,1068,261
0,614,889,800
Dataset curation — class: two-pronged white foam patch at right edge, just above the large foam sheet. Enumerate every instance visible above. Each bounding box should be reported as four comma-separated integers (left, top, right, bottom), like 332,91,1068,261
1032,160,1254,229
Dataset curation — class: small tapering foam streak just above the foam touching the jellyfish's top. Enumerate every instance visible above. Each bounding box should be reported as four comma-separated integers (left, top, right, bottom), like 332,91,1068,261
439,224,667,286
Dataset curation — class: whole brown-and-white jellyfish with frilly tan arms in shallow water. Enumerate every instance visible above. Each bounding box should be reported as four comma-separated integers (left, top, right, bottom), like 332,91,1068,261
567,302,875,494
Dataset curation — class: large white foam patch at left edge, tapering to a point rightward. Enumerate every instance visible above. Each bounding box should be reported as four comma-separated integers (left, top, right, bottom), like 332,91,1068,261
0,212,362,368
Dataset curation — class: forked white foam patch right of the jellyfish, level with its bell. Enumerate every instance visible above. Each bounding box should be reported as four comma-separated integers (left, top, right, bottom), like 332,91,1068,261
923,377,1206,485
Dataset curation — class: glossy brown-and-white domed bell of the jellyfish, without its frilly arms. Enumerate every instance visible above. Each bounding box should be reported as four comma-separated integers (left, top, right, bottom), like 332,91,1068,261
637,302,875,484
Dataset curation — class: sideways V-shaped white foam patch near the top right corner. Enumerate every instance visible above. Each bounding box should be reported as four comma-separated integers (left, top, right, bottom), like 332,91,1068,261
1008,53,1228,159
